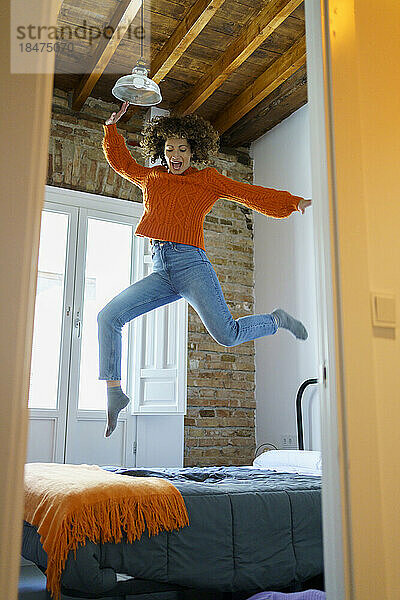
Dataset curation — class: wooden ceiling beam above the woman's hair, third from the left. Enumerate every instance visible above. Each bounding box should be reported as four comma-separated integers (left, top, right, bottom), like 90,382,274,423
174,0,303,116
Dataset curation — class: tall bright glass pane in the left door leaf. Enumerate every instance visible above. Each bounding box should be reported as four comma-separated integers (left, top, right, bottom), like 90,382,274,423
28,211,69,408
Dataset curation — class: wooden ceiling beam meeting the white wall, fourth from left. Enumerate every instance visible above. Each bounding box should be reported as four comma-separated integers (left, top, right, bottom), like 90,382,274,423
212,35,306,134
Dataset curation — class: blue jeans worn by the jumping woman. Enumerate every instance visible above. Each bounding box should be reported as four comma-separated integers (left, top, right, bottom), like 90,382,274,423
97,242,277,380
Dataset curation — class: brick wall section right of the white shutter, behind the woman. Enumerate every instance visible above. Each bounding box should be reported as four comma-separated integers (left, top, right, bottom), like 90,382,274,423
185,171,255,465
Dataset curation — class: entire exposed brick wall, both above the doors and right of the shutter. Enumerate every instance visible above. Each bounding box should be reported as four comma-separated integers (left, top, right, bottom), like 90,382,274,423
47,90,255,466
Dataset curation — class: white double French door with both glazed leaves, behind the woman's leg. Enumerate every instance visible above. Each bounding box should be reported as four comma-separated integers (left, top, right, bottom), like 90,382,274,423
27,193,137,465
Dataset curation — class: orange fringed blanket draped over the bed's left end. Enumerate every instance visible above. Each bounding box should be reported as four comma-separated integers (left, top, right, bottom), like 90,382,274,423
24,463,189,600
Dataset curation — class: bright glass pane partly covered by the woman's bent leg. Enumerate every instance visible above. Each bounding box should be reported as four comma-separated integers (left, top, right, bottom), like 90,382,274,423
78,218,133,410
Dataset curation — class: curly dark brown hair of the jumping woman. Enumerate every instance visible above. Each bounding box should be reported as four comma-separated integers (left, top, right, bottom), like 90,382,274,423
140,115,219,166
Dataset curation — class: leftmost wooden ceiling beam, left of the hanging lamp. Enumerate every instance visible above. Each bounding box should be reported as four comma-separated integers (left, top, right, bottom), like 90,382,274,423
72,0,142,111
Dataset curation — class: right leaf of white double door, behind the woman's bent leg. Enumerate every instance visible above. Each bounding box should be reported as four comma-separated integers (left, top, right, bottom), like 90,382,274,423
65,208,135,465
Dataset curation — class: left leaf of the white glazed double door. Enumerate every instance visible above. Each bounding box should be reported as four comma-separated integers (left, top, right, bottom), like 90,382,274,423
27,205,73,462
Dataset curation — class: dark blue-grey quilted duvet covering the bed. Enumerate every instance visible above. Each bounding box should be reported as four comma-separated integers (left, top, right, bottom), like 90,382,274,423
22,467,323,594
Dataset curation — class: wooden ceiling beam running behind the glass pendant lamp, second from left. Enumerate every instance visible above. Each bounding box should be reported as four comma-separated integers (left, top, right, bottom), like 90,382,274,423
120,0,225,122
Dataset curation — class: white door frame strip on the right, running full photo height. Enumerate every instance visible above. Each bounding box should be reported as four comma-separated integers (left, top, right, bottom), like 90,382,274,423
305,0,348,600
